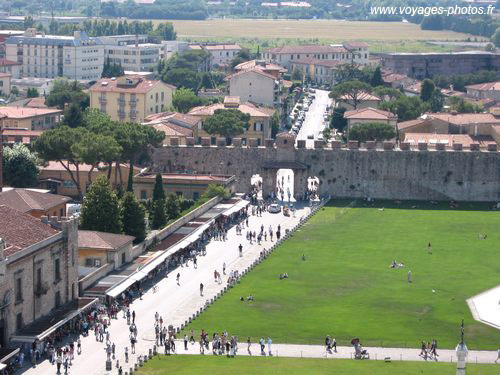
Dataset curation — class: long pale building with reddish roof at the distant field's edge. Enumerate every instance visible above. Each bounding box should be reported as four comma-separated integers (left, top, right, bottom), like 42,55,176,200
262,42,370,70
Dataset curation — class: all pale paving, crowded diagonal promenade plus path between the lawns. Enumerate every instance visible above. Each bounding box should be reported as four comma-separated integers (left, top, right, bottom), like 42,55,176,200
17,203,496,375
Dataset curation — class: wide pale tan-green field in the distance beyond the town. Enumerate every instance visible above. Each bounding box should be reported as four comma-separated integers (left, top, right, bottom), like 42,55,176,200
153,19,481,52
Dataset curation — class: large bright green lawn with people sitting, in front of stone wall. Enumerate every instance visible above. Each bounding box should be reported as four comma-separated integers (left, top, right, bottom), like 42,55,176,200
182,202,500,350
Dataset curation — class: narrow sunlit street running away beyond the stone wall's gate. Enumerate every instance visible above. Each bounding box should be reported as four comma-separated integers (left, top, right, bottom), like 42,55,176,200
297,89,332,148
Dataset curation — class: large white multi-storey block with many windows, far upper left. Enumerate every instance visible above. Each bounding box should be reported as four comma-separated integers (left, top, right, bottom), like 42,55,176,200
5,29,104,81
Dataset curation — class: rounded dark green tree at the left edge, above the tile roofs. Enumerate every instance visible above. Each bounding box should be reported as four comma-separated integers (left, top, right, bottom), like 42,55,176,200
2,143,39,188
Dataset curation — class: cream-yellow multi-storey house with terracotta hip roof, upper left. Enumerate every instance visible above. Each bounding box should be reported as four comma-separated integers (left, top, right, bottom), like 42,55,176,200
89,76,175,122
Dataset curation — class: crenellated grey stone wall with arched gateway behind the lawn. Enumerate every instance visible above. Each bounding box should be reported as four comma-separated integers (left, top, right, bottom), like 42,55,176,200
152,133,500,202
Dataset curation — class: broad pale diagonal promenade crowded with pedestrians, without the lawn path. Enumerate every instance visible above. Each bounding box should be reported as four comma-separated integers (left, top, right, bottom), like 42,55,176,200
24,206,310,375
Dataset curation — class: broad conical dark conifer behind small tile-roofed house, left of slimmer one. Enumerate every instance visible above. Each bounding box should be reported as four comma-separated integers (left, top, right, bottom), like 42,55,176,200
80,176,122,233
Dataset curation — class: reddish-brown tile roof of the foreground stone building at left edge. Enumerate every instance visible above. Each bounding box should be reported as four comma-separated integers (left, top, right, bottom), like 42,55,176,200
0,205,60,257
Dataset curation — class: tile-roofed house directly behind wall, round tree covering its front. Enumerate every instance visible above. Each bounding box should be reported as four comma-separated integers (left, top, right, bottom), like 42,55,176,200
188,96,275,146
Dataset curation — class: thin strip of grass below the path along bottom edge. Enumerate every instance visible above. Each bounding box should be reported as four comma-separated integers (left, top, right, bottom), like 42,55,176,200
138,355,499,375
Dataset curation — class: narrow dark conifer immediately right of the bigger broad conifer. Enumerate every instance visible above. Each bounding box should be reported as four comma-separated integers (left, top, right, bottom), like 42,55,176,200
121,191,146,243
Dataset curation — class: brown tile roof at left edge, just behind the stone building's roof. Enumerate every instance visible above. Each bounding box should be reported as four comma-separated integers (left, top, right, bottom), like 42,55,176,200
0,189,71,213
